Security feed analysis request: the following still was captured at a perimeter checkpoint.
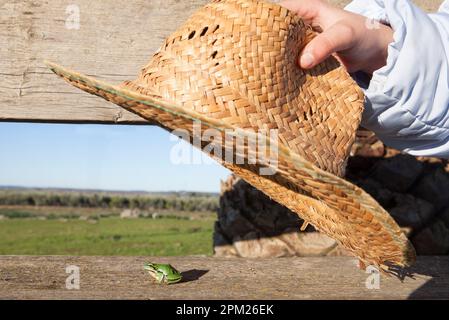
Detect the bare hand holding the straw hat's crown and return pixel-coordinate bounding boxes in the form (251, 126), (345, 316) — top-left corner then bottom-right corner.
(280, 0), (393, 74)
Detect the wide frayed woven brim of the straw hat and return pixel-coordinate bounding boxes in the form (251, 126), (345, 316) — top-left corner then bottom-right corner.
(46, 62), (415, 269)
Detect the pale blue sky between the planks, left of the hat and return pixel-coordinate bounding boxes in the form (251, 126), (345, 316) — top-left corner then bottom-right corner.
(0, 123), (229, 192)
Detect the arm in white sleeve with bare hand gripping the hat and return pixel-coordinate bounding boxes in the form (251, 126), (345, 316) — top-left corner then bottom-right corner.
(281, 0), (449, 158)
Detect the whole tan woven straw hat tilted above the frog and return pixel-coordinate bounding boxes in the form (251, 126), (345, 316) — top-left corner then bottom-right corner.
(48, 0), (415, 269)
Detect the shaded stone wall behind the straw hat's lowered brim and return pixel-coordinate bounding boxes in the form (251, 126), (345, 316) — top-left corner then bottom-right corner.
(214, 130), (449, 257)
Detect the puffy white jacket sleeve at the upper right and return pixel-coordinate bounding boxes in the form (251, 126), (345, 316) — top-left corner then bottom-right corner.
(345, 0), (449, 158)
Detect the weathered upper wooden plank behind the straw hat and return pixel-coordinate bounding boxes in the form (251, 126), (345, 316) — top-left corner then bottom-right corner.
(0, 0), (441, 124)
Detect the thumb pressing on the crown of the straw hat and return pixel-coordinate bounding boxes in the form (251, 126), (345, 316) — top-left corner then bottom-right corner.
(299, 22), (355, 69)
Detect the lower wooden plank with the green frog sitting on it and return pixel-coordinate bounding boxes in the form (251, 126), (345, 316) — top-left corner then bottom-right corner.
(0, 256), (449, 300)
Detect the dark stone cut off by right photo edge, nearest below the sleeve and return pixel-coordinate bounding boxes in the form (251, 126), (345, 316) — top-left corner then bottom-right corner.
(412, 166), (449, 210)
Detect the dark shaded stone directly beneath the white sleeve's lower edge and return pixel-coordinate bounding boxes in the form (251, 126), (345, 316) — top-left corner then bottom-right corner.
(372, 154), (423, 192)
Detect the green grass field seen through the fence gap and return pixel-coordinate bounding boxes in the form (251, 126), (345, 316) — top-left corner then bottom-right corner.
(0, 215), (215, 256)
